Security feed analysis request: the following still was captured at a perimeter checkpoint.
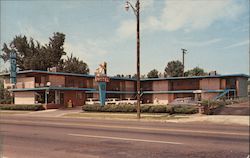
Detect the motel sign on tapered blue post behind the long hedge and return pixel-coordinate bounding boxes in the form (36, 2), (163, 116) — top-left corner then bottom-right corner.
(95, 62), (110, 106)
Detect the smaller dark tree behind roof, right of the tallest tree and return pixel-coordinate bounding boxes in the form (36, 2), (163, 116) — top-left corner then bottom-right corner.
(59, 54), (89, 74)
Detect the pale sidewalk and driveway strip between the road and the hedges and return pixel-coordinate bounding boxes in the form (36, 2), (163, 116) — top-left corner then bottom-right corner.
(2, 107), (250, 126)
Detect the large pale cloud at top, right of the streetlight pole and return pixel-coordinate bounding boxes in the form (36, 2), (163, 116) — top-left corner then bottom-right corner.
(147, 0), (244, 31)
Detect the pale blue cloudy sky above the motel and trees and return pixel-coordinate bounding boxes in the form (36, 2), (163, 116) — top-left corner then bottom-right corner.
(0, 0), (249, 75)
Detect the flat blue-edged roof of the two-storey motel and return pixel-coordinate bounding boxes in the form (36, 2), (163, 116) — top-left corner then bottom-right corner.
(0, 70), (249, 81)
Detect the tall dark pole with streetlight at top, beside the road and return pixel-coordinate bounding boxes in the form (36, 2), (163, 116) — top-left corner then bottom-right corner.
(125, 0), (141, 119)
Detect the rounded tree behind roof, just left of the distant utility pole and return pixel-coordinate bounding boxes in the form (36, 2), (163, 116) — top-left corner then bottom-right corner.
(165, 60), (184, 77)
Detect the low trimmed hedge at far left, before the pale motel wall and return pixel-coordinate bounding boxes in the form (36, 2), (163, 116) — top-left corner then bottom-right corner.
(0, 105), (44, 111)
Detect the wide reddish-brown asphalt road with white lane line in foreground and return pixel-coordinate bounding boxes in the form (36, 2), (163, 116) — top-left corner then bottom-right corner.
(0, 115), (249, 158)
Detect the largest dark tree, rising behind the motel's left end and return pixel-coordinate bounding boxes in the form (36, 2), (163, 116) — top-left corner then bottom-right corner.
(0, 32), (66, 70)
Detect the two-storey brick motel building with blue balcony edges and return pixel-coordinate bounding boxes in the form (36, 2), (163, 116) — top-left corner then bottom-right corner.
(0, 70), (249, 109)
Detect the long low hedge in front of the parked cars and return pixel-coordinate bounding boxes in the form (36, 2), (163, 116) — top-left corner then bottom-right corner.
(82, 104), (198, 114)
